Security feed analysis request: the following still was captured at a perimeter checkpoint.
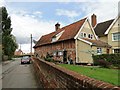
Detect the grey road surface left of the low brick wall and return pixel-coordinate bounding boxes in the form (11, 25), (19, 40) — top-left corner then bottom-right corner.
(2, 59), (40, 88)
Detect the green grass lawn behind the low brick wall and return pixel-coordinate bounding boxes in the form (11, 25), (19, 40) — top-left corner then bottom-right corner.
(60, 64), (120, 86)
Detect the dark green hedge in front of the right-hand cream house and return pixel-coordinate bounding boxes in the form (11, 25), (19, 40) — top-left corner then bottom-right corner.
(93, 54), (120, 65)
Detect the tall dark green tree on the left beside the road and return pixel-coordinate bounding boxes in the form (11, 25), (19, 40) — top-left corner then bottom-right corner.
(1, 7), (18, 59)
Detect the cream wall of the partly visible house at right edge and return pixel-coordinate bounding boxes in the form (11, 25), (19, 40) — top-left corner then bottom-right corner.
(108, 18), (120, 53)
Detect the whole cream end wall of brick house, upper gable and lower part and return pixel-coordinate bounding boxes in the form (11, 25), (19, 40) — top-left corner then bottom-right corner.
(76, 20), (96, 63)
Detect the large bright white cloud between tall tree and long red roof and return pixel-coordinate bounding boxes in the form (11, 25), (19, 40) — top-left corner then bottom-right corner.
(10, 11), (56, 53)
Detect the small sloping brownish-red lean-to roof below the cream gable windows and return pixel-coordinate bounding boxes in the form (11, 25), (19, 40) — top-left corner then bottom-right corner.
(83, 38), (111, 48)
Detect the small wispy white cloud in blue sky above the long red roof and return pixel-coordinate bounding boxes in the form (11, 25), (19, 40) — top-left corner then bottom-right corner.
(56, 9), (79, 18)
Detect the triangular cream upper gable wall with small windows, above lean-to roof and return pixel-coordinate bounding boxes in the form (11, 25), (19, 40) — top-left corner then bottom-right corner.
(79, 20), (95, 40)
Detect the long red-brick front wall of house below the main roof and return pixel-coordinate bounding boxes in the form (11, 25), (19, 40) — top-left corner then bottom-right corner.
(35, 40), (76, 61)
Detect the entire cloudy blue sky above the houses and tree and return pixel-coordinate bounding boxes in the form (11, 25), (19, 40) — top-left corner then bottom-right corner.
(0, 0), (119, 53)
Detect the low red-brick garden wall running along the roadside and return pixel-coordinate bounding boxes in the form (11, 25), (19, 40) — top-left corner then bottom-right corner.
(33, 58), (120, 90)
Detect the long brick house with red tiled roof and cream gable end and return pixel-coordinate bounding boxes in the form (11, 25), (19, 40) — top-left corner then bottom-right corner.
(34, 14), (111, 63)
